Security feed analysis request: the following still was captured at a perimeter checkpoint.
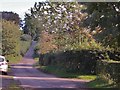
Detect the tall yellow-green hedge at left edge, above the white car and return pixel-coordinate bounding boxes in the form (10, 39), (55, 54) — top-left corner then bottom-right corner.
(2, 20), (20, 56)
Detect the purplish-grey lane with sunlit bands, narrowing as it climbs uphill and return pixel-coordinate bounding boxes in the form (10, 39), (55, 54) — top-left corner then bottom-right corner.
(12, 41), (87, 90)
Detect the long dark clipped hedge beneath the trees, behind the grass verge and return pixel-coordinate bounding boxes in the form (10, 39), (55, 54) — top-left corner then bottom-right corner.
(39, 50), (119, 74)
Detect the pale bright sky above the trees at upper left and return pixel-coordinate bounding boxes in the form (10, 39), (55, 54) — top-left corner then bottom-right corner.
(0, 0), (44, 19)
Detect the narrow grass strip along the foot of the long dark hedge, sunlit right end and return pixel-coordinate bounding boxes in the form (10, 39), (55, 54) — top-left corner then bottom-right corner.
(34, 63), (96, 80)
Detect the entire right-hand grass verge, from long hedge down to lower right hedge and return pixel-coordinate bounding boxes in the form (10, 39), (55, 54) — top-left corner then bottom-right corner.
(34, 62), (116, 88)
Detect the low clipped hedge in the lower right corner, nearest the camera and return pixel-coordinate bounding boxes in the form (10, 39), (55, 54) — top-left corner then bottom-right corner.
(97, 60), (120, 87)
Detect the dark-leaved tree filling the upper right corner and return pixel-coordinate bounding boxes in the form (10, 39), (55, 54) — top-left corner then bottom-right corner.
(84, 2), (120, 48)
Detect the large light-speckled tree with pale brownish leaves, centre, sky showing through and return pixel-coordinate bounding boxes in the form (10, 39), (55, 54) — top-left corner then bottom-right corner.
(26, 2), (102, 50)
